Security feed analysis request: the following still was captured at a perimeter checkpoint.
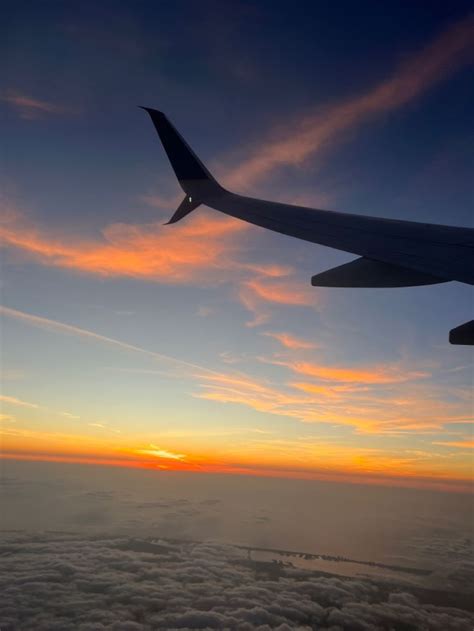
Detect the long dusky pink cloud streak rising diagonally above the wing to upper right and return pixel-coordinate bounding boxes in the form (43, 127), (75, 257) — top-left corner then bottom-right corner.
(223, 16), (474, 189)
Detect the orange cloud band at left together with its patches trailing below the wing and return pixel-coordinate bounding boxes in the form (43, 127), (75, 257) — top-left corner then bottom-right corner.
(0, 207), (304, 325)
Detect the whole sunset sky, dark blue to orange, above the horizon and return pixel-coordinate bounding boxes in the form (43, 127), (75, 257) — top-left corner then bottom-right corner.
(0, 1), (474, 492)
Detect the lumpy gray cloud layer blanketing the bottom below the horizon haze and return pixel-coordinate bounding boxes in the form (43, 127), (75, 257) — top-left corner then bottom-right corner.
(0, 534), (474, 631)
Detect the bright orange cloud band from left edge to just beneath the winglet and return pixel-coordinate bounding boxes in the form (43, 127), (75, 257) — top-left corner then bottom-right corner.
(0, 213), (252, 283)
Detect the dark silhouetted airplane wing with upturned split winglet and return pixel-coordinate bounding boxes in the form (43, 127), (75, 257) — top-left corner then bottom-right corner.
(143, 107), (474, 344)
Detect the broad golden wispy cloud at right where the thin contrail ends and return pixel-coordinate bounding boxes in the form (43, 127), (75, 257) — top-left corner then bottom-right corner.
(194, 368), (464, 436)
